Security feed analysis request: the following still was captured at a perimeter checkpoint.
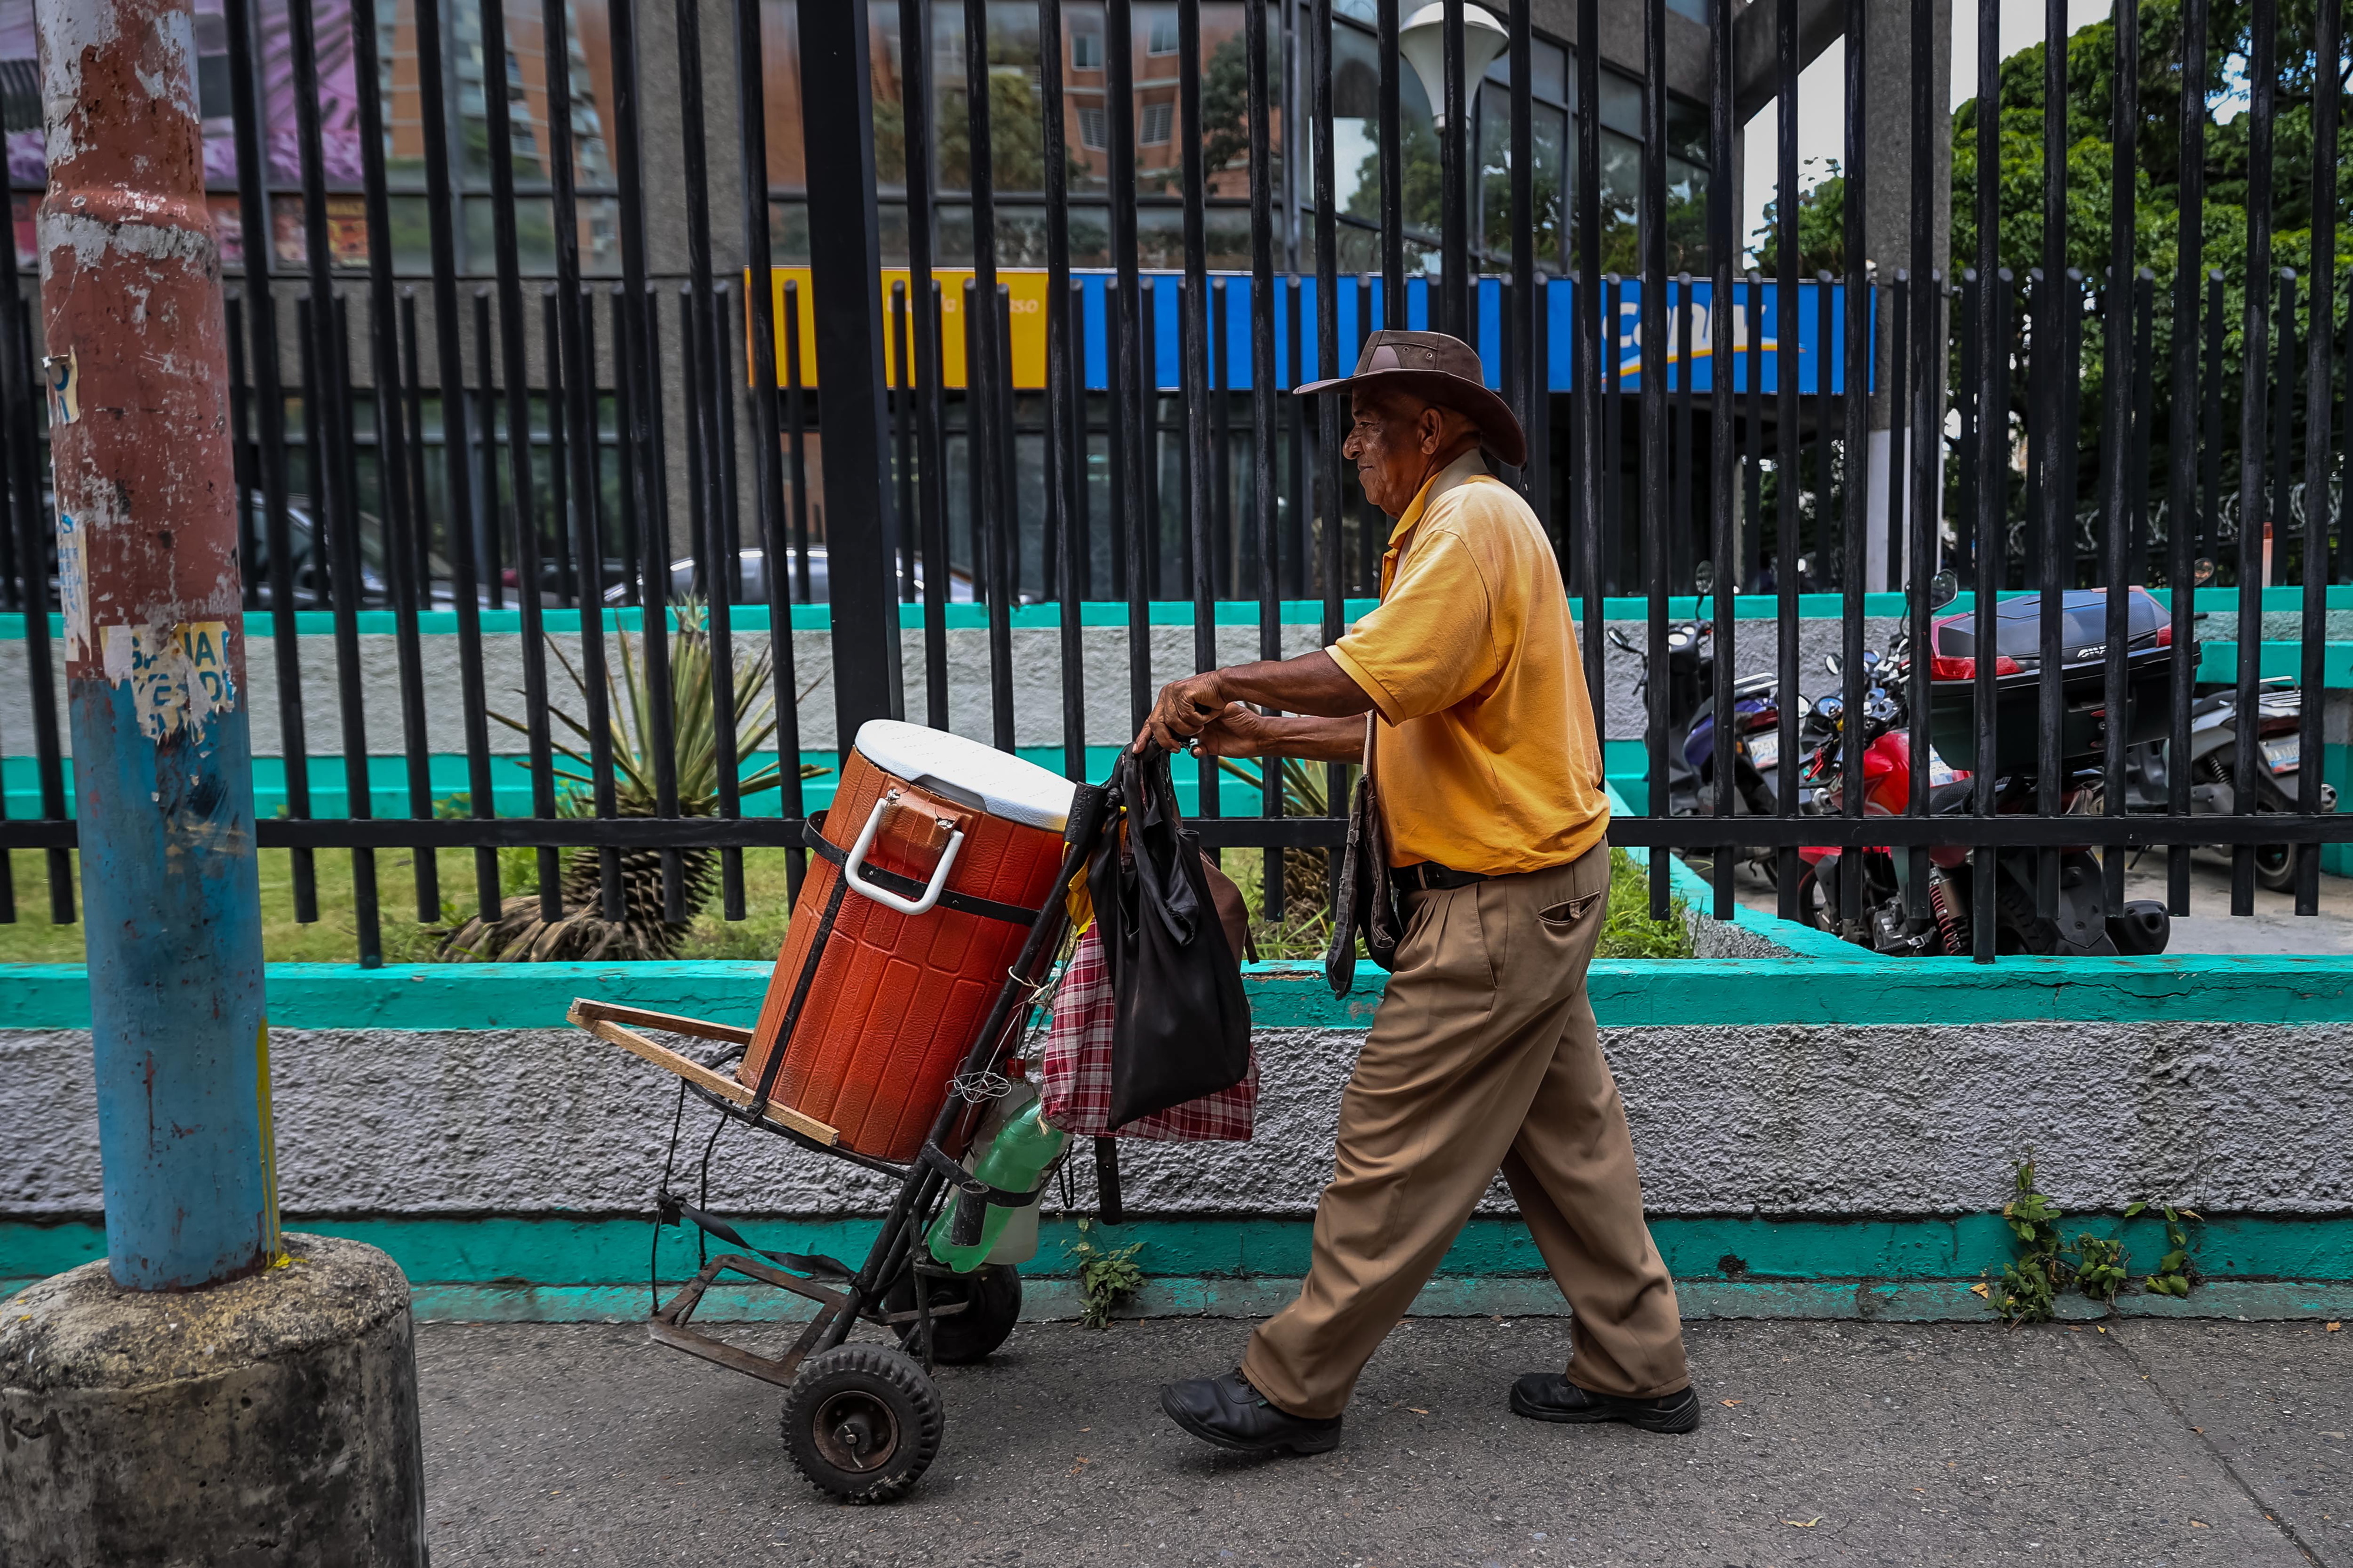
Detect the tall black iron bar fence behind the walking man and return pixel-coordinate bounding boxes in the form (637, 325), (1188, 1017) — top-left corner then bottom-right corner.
(0, 0), (2353, 963)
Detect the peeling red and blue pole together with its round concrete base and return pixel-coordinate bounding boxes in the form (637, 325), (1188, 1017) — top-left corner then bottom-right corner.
(0, 0), (424, 1563)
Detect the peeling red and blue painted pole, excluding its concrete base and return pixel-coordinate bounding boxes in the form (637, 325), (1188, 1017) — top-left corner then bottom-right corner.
(35, 0), (278, 1290)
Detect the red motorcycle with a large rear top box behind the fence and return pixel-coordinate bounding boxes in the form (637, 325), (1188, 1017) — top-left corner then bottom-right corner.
(1798, 591), (2172, 956)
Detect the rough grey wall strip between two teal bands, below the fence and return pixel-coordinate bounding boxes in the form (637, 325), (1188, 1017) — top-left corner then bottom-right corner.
(0, 1022), (2353, 1220)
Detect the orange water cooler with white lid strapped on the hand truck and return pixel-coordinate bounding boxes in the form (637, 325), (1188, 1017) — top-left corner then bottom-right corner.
(736, 718), (1073, 1160)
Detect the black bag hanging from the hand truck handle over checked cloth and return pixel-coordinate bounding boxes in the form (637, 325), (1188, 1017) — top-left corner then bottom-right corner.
(1087, 749), (1249, 1125)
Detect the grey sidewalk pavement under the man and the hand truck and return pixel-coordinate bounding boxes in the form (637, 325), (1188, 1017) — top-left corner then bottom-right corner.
(419, 1319), (2353, 1568)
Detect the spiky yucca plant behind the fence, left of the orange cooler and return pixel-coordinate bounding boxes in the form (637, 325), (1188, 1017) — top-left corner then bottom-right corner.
(440, 600), (826, 963)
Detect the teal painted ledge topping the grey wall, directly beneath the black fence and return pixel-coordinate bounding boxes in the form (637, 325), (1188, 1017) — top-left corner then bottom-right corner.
(0, 946), (2353, 1029)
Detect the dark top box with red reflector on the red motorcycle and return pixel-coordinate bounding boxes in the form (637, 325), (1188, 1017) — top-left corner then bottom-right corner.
(1929, 589), (2198, 772)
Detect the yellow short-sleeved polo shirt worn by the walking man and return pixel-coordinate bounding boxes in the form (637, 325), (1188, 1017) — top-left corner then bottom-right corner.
(1329, 452), (1609, 876)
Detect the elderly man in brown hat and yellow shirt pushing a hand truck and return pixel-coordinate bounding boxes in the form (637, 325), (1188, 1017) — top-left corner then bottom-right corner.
(1136, 332), (1699, 1453)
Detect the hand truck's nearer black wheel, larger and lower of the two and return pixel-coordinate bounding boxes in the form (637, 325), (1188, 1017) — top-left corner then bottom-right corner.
(784, 1345), (946, 1502)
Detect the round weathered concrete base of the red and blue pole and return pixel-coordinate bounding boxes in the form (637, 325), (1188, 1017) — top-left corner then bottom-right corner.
(0, 1234), (426, 1568)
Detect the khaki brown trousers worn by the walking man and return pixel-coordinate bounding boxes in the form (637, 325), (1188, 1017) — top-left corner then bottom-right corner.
(1242, 843), (1692, 1417)
